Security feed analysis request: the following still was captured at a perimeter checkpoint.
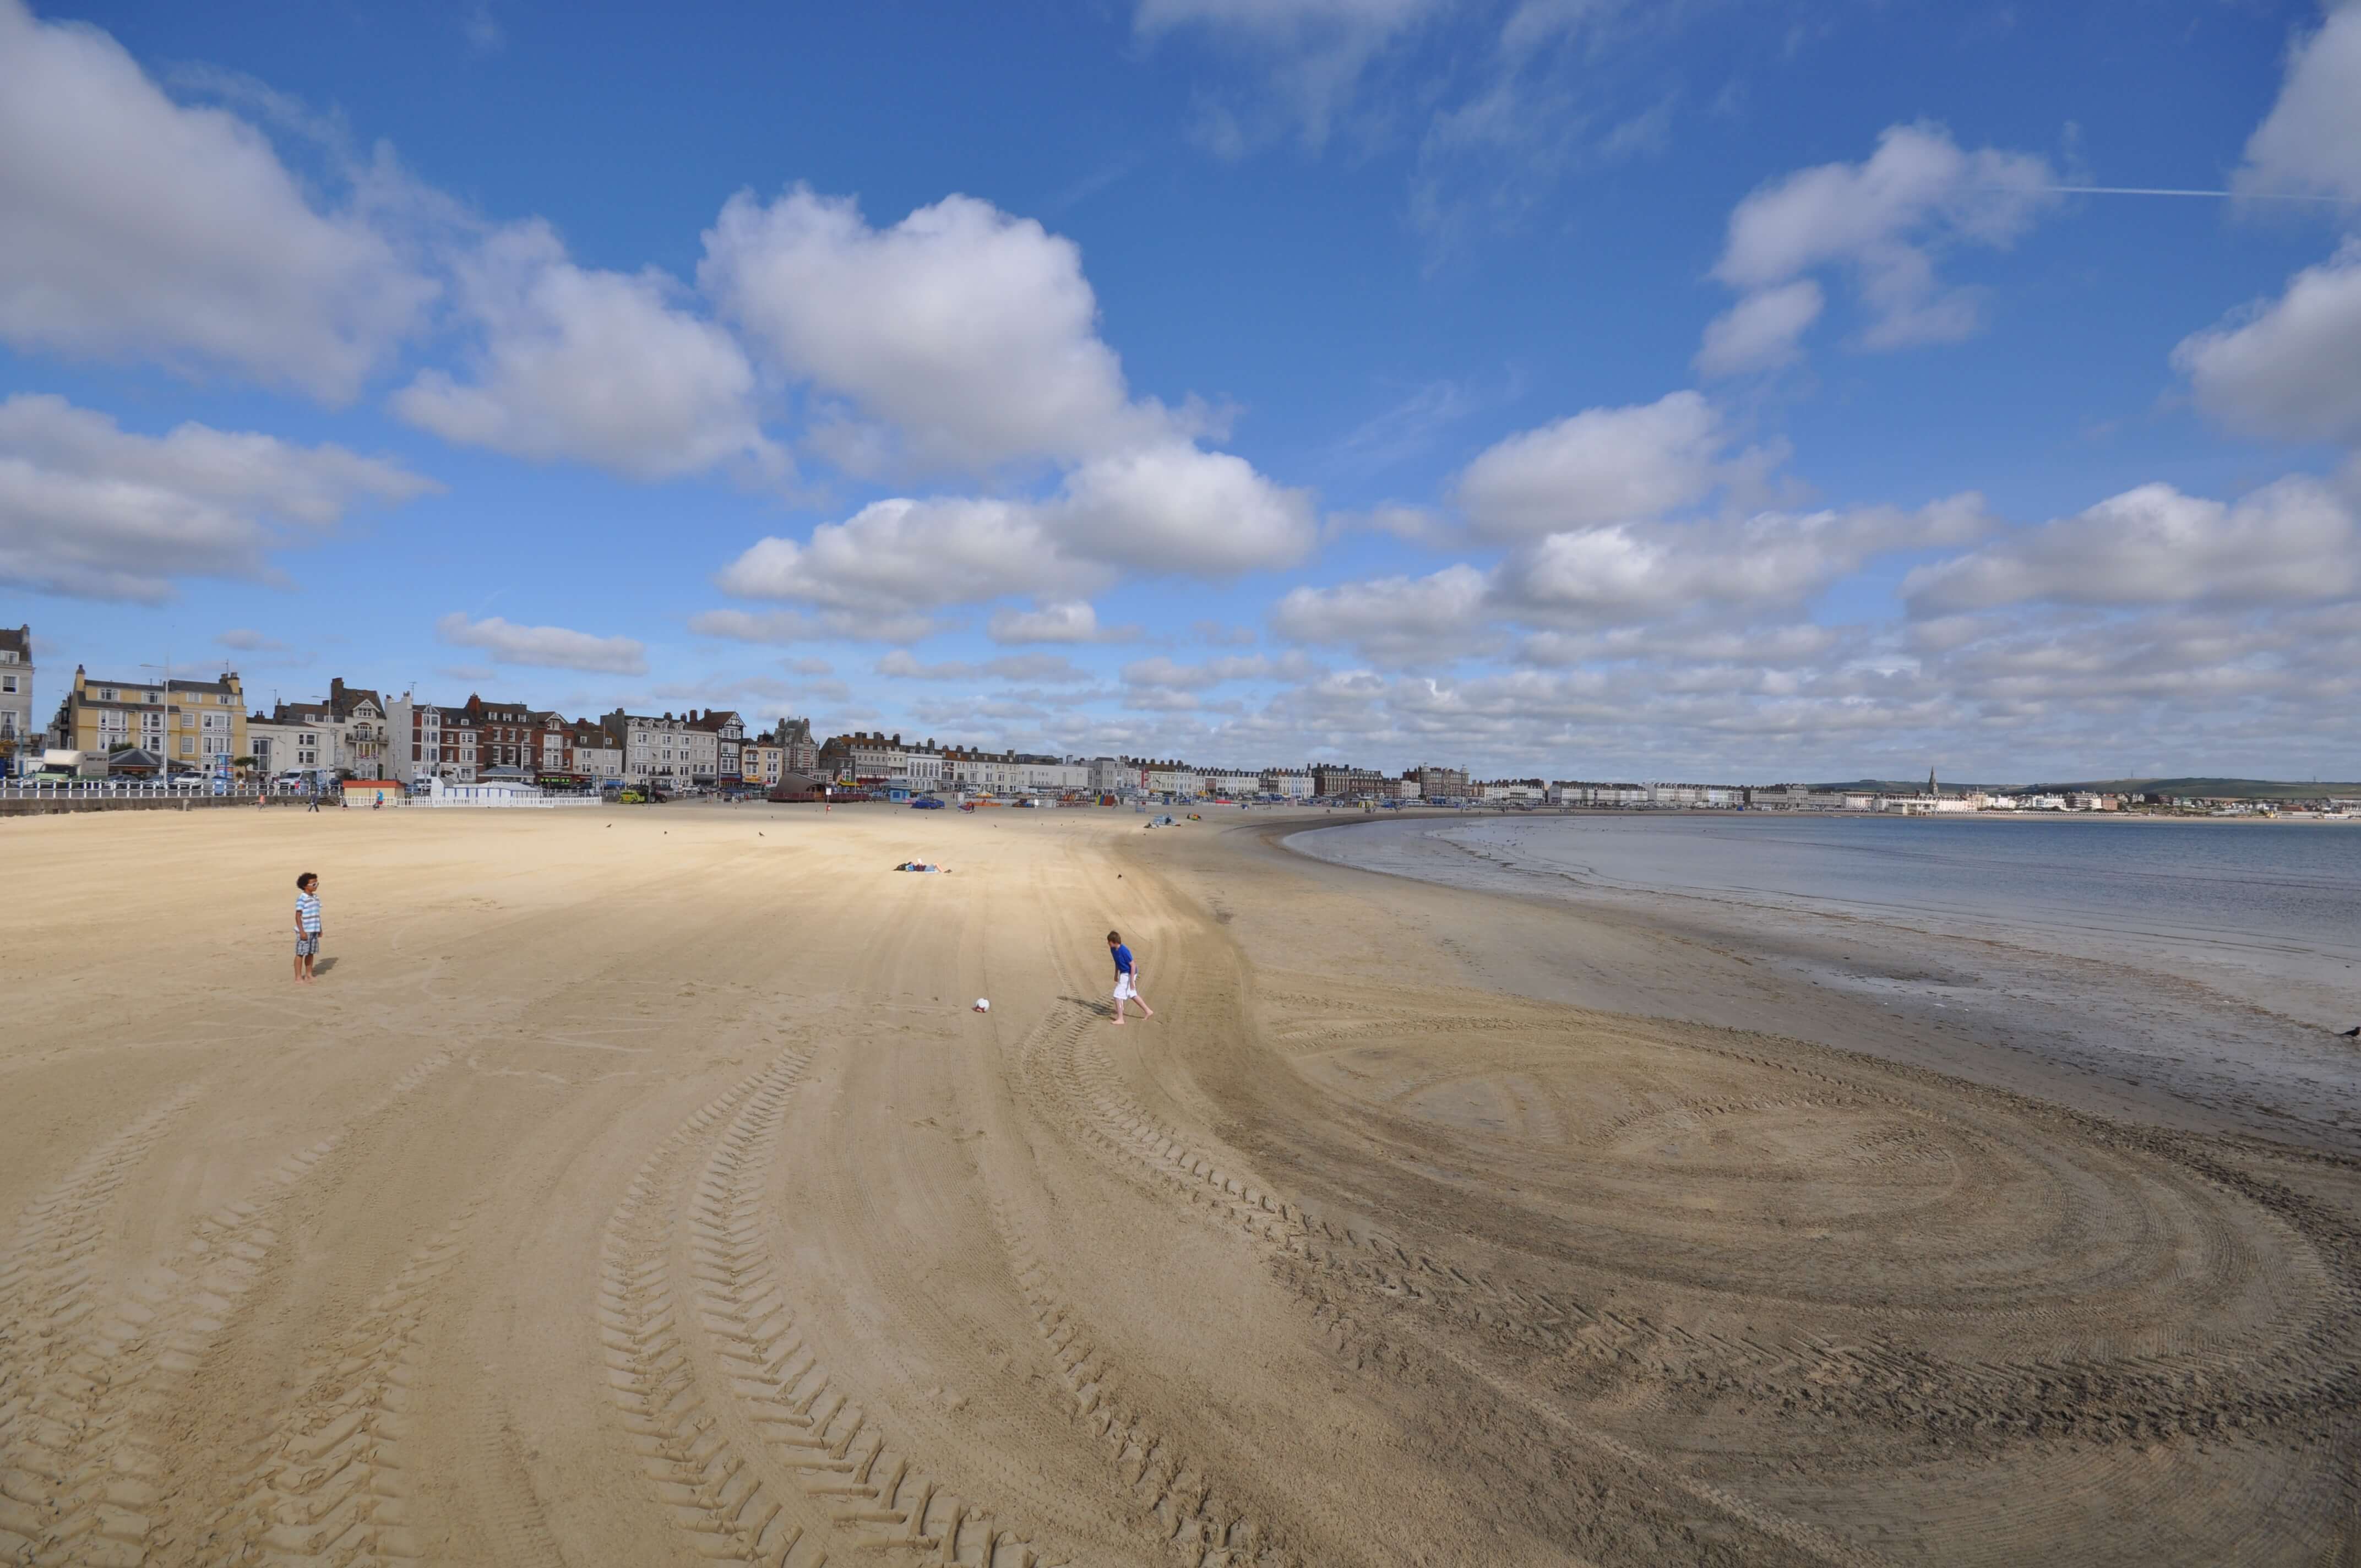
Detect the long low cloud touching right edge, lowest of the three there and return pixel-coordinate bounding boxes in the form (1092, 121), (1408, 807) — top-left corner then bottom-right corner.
(1903, 477), (2361, 616)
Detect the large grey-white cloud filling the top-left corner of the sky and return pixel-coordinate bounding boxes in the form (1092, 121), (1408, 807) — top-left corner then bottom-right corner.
(0, 0), (434, 401)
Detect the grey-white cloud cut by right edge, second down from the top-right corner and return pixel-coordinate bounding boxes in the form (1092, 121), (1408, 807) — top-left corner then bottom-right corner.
(2172, 238), (2361, 442)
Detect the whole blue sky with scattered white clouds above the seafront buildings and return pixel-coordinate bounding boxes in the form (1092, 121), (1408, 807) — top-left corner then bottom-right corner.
(0, 0), (2361, 779)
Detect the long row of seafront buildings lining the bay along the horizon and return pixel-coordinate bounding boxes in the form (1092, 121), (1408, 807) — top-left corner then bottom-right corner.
(23, 647), (2304, 817)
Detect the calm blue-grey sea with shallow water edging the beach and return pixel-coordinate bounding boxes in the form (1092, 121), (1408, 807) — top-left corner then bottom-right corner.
(1289, 812), (2361, 1147)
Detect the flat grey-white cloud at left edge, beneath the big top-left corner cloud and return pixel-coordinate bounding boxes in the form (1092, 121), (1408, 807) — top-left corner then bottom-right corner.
(0, 392), (439, 602)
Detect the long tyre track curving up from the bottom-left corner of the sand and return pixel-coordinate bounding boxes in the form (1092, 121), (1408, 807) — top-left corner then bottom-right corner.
(0, 1051), (456, 1568)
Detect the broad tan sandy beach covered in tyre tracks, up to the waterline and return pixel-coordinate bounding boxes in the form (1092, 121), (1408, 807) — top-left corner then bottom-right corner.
(0, 808), (2361, 1568)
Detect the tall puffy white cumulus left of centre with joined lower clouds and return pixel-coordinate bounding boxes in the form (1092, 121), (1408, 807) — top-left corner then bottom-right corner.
(699, 189), (1318, 618)
